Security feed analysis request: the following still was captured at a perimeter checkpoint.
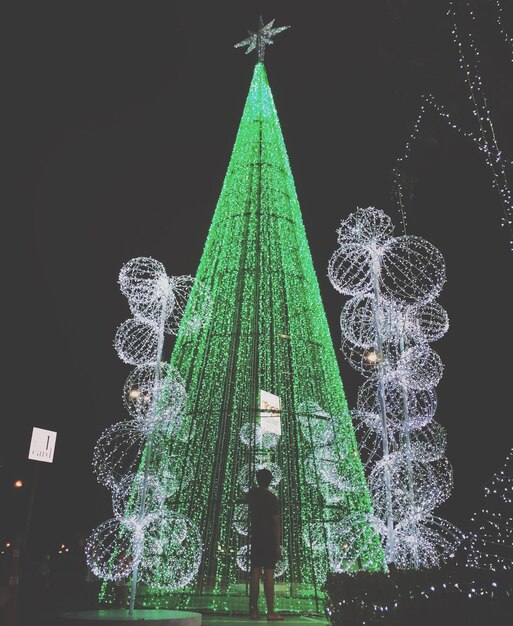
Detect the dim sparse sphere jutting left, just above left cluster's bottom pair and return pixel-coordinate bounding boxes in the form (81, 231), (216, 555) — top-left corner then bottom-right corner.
(93, 420), (145, 489)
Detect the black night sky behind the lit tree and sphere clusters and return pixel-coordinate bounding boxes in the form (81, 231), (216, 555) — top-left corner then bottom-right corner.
(4, 0), (513, 549)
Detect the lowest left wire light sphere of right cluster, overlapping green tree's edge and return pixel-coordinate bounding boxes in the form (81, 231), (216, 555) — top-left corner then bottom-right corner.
(326, 513), (379, 572)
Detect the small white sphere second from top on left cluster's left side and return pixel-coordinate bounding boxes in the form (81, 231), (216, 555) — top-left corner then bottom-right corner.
(114, 319), (159, 365)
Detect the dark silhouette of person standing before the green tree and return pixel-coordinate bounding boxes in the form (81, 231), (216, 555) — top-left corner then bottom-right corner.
(248, 468), (283, 622)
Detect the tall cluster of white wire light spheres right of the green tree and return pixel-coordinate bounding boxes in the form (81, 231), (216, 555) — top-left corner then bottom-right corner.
(328, 207), (461, 571)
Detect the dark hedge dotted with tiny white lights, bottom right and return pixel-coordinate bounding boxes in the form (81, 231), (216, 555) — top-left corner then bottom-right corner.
(326, 568), (513, 626)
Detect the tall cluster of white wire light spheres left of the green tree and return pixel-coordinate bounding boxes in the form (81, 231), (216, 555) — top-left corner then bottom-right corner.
(86, 257), (211, 590)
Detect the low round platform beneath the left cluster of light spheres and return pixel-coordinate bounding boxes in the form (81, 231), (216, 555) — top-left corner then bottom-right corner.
(60, 609), (201, 626)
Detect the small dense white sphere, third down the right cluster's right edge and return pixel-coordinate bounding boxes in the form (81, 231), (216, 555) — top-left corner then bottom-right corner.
(397, 344), (444, 389)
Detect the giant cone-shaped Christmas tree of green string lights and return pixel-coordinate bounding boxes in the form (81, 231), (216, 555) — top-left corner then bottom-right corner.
(156, 62), (384, 606)
